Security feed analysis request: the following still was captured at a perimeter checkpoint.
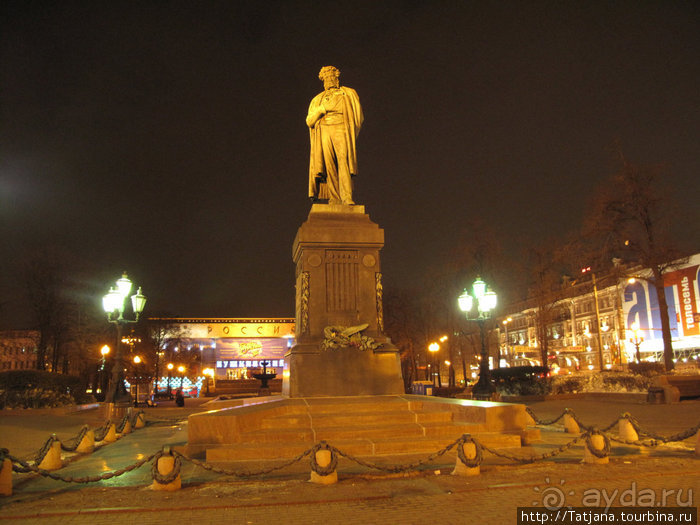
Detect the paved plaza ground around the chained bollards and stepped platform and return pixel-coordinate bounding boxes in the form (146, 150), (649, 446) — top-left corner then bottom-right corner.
(0, 398), (700, 524)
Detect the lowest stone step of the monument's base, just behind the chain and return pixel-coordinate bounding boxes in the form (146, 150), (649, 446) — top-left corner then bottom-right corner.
(206, 432), (520, 463)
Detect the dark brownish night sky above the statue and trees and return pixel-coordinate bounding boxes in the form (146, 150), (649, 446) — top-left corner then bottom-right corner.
(0, 0), (700, 322)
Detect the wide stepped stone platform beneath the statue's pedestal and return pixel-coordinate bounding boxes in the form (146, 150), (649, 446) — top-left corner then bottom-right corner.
(187, 395), (539, 462)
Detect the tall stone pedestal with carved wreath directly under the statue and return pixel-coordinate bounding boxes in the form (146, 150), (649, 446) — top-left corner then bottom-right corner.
(282, 204), (403, 397)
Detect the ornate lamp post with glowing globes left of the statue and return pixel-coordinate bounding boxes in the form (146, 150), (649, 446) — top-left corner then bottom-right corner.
(102, 272), (146, 404)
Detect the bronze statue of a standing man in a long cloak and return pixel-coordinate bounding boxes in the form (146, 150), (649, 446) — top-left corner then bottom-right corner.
(306, 66), (364, 204)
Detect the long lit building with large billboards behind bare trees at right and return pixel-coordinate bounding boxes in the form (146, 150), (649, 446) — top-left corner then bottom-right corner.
(499, 254), (700, 370)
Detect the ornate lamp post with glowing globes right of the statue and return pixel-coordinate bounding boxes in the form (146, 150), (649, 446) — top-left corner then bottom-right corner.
(458, 277), (497, 400)
